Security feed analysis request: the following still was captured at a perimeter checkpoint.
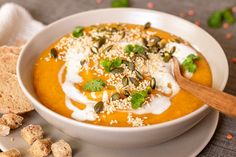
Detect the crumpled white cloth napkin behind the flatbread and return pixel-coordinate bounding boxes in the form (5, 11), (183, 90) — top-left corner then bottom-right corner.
(0, 3), (44, 46)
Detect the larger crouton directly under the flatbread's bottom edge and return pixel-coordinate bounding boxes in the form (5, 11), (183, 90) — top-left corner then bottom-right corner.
(2, 113), (24, 129)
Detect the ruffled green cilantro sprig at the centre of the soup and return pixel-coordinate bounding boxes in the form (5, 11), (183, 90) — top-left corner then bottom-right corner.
(100, 57), (122, 72)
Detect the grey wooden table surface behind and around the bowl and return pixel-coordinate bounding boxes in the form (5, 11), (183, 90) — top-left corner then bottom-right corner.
(0, 0), (236, 157)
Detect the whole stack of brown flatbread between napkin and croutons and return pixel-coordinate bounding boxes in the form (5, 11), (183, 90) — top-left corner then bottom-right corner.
(0, 46), (33, 114)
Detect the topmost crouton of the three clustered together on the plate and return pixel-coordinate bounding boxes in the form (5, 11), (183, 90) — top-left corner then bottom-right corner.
(21, 124), (43, 145)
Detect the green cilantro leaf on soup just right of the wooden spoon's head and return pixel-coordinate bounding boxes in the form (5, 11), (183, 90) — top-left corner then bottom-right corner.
(182, 54), (200, 73)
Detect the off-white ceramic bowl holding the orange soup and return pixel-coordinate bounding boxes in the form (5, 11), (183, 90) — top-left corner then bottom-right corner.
(17, 9), (228, 147)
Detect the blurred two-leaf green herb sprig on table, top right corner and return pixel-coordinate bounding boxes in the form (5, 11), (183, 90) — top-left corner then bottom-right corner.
(208, 8), (235, 28)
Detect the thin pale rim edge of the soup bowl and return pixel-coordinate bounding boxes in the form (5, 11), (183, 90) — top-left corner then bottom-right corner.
(16, 8), (229, 132)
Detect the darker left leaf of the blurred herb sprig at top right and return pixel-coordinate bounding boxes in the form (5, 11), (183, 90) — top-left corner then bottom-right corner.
(208, 11), (223, 28)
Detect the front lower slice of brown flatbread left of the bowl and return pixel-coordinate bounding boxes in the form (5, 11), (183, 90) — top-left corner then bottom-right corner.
(0, 72), (33, 114)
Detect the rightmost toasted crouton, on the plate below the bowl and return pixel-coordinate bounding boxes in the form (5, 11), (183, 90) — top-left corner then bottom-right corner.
(51, 140), (72, 157)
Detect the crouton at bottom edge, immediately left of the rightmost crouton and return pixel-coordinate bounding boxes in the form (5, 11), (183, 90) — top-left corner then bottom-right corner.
(28, 138), (52, 157)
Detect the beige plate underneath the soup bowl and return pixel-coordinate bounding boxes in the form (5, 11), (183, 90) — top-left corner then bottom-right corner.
(0, 111), (219, 157)
